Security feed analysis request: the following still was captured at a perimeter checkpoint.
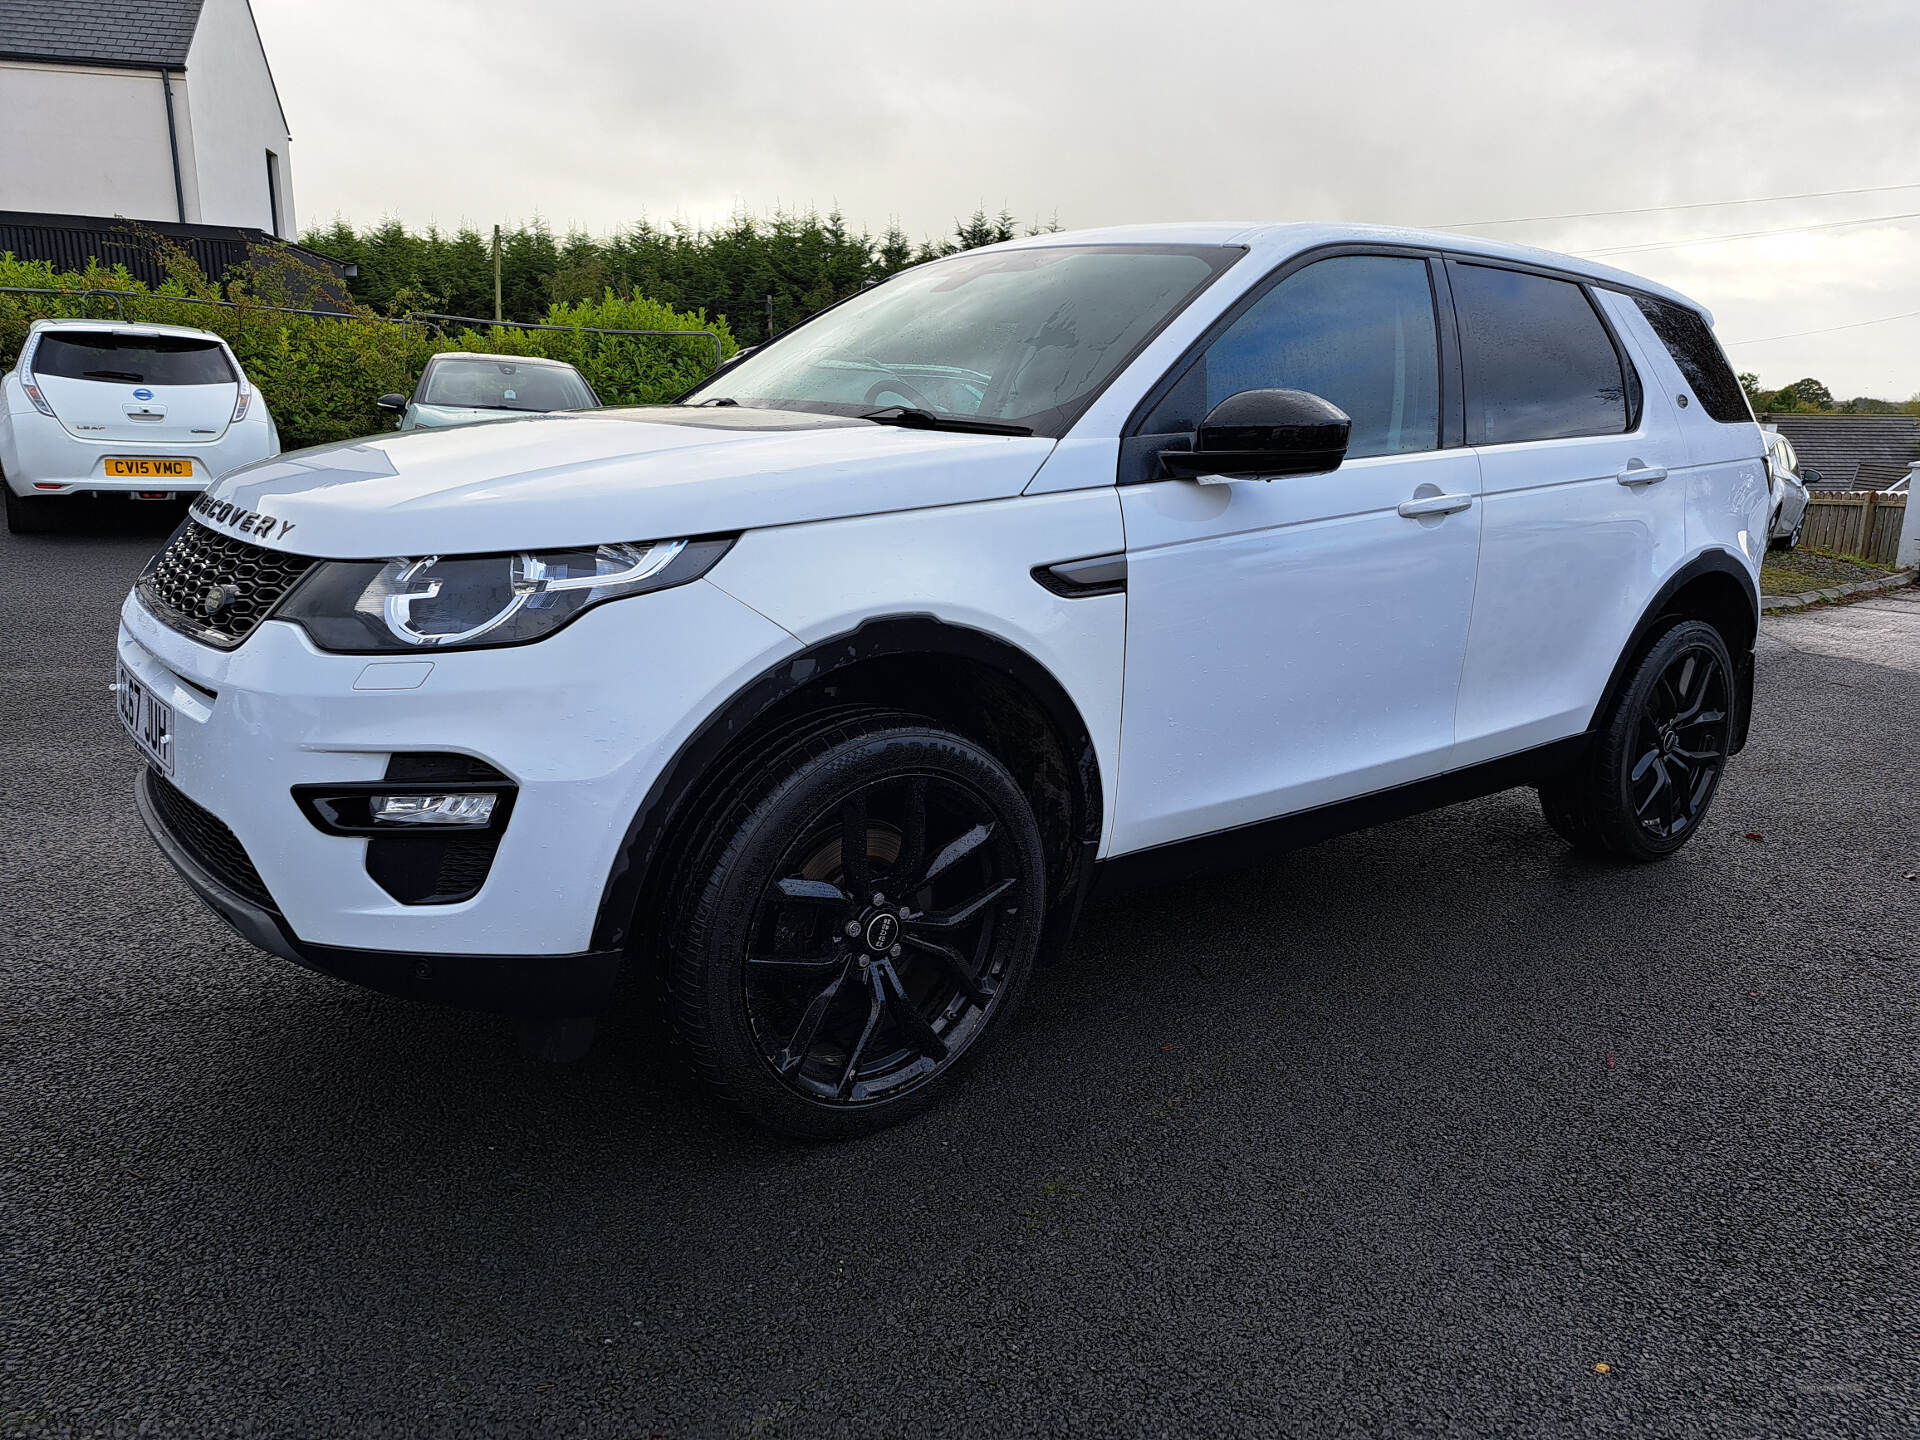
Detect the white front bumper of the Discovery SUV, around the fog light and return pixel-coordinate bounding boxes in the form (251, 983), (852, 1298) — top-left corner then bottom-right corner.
(119, 580), (799, 993)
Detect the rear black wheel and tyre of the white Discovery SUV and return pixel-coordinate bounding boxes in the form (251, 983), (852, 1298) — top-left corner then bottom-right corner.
(1540, 620), (1736, 860)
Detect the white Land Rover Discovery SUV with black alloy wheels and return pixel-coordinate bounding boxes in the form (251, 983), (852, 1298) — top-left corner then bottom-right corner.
(119, 225), (1768, 1135)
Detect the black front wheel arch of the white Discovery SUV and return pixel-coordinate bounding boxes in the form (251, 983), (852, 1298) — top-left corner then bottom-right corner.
(593, 614), (1104, 952)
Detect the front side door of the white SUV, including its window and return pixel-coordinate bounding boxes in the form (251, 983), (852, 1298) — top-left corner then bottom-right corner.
(1110, 252), (1480, 854)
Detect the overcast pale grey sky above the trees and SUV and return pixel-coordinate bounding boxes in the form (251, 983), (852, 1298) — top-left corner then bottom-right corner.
(253, 0), (1920, 399)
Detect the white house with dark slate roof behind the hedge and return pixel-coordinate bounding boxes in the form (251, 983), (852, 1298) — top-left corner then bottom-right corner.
(0, 0), (294, 238)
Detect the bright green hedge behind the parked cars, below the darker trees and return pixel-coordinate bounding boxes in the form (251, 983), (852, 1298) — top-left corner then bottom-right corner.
(0, 255), (737, 449)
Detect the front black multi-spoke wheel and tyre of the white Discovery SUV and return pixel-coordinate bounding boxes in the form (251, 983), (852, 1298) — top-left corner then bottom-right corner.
(660, 712), (1046, 1139)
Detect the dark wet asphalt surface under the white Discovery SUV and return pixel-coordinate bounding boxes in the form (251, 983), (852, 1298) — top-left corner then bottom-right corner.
(0, 510), (1920, 1436)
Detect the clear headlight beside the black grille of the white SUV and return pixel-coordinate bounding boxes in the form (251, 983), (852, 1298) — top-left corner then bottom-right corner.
(275, 538), (733, 653)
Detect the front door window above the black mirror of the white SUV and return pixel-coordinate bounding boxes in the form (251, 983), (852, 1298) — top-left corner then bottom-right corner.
(1142, 255), (1440, 459)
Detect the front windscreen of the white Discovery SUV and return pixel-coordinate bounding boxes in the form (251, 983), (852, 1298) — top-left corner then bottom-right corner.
(685, 246), (1242, 436)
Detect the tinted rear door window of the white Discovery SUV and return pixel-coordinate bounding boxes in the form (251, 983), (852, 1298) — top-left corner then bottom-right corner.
(1452, 265), (1632, 445)
